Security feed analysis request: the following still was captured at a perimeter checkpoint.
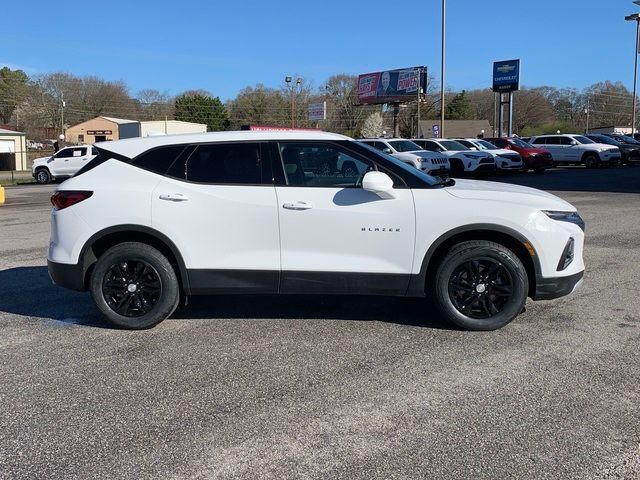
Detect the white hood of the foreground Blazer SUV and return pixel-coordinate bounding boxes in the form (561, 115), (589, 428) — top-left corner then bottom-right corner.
(446, 179), (576, 212)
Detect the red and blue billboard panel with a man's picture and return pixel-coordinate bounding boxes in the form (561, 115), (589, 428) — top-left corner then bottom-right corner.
(358, 67), (426, 103)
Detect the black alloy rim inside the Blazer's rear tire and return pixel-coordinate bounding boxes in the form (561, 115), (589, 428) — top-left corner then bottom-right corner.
(102, 260), (162, 318)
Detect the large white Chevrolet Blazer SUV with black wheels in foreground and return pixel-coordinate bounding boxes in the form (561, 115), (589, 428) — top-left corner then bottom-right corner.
(48, 131), (584, 330)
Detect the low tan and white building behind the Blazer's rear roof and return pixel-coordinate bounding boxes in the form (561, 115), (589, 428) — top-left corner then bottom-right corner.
(65, 117), (207, 144)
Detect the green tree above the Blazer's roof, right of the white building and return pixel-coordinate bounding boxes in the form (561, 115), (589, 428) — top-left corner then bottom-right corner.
(175, 91), (230, 131)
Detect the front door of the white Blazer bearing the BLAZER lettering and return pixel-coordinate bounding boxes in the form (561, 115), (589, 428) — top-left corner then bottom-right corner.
(272, 141), (415, 294)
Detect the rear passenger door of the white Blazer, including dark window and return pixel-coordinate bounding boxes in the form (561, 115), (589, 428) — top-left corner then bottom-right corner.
(151, 142), (280, 293)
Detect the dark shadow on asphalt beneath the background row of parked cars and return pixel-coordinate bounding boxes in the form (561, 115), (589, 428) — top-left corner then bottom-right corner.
(486, 165), (640, 193)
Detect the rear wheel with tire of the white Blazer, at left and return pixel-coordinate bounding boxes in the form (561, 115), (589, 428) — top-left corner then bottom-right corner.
(90, 242), (180, 330)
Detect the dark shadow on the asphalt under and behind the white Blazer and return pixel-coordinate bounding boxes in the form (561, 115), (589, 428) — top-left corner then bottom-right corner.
(0, 267), (457, 330)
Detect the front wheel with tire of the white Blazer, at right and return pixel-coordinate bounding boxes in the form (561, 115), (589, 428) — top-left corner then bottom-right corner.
(431, 240), (529, 331)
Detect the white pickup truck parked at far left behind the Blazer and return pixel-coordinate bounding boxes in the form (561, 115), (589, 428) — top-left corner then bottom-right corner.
(31, 145), (98, 184)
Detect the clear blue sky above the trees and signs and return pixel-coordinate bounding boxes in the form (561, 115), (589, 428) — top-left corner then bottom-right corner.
(0, 0), (640, 100)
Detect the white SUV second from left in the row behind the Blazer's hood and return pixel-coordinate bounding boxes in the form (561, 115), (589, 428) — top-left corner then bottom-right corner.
(411, 138), (496, 176)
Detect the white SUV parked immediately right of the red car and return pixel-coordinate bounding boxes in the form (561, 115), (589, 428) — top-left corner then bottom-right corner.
(531, 134), (620, 168)
